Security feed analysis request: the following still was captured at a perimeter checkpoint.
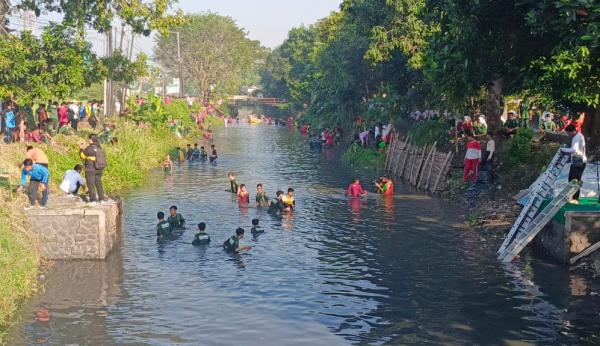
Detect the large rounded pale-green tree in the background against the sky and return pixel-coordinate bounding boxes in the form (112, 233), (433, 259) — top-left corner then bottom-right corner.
(154, 12), (266, 99)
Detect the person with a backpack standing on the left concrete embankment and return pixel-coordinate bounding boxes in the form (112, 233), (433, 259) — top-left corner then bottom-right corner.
(79, 134), (106, 203)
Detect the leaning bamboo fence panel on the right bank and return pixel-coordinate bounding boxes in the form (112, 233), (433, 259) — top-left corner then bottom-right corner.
(385, 137), (454, 192)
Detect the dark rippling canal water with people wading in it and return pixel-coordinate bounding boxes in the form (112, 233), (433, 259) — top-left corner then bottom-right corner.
(9, 125), (600, 345)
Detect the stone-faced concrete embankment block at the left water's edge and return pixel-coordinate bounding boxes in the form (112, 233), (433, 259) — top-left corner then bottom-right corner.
(26, 201), (123, 260)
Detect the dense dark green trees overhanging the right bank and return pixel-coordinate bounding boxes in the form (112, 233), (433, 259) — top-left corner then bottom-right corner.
(261, 0), (600, 137)
